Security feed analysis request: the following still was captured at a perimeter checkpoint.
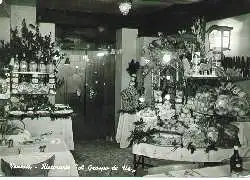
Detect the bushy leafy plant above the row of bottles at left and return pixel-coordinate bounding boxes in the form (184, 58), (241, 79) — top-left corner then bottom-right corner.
(0, 19), (63, 78)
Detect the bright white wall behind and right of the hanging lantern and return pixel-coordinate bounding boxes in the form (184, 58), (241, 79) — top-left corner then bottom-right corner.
(207, 13), (250, 56)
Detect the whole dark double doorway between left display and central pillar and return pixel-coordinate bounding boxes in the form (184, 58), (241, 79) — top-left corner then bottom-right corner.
(57, 51), (115, 140)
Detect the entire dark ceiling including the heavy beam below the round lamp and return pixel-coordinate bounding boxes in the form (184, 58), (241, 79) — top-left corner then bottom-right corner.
(37, 0), (250, 48)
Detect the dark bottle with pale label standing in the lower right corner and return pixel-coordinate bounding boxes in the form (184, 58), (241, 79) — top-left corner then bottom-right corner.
(230, 146), (243, 176)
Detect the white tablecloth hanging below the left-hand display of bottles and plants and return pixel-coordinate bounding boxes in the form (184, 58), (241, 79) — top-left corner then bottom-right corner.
(23, 117), (74, 150)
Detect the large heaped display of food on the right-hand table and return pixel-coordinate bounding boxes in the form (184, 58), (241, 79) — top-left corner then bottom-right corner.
(132, 83), (249, 153)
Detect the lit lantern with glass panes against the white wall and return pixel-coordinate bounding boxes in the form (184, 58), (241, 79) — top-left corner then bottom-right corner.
(208, 25), (233, 51)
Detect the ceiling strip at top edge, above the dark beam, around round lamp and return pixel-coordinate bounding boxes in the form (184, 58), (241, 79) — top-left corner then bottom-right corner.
(38, 0), (201, 15)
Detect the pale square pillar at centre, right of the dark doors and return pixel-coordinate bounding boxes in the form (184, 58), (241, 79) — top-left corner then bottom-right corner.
(115, 28), (138, 134)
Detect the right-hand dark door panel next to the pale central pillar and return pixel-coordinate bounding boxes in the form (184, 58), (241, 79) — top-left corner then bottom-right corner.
(84, 51), (115, 139)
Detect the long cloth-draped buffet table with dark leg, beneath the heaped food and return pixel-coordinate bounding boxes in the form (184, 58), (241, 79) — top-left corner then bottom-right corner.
(132, 122), (250, 173)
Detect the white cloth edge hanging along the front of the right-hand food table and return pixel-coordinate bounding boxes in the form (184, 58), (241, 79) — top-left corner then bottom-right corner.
(132, 143), (250, 162)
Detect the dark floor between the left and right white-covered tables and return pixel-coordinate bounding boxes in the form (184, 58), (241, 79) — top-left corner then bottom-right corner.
(72, 140), (179, 177)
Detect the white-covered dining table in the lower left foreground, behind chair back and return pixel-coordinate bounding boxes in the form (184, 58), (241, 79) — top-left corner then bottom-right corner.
(0, 137), (79, 177)
